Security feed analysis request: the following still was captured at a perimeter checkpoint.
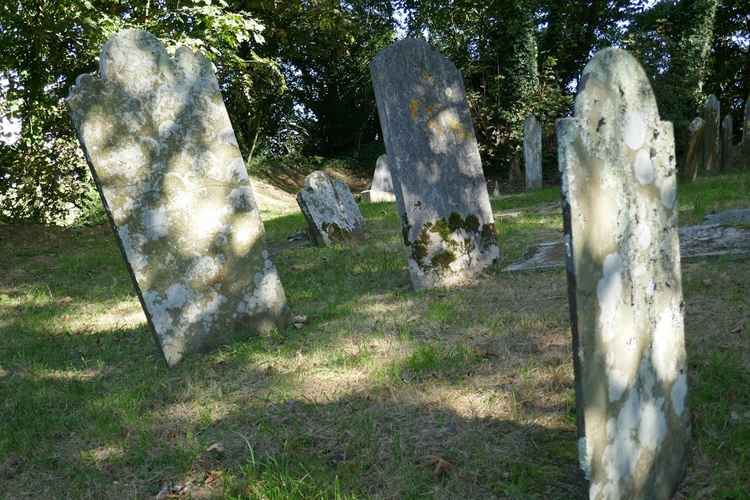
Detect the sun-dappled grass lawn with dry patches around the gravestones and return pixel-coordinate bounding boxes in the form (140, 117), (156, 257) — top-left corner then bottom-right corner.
(0, 174), (750, 499)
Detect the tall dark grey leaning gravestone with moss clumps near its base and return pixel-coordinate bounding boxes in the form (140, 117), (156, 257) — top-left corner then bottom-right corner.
(370, 39), (500, 289)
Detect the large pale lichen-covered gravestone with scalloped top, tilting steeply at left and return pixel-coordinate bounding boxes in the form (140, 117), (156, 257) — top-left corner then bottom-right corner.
(67, 30), (287, 366)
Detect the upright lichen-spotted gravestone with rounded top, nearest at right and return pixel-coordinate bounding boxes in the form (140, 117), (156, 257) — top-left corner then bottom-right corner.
(557, 49), (690, 500)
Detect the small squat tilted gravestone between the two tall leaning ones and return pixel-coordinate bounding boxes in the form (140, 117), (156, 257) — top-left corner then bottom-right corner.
(297, 171), (364, 246)
